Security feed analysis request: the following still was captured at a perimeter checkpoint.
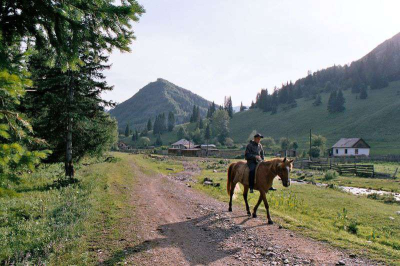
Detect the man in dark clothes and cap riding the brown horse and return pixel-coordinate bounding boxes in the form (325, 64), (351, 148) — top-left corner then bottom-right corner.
(244, 133), (276, 193)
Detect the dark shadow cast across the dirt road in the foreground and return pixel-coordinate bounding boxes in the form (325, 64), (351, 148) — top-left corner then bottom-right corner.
(99, 214), (247, 265)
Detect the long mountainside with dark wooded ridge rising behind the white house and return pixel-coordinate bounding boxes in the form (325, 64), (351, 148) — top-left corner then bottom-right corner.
(230, 33), (400, 155)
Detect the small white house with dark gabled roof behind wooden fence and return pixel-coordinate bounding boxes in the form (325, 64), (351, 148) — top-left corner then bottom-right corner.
(332, 138), (371, 157)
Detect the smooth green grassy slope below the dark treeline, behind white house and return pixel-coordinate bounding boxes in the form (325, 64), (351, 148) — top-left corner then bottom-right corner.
(230, 81), (400, 155)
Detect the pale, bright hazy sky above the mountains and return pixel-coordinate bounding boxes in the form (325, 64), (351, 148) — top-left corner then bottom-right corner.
(103, 0), (400, 106)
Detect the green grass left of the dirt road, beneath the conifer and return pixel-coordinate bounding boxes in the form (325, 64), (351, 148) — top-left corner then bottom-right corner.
(0, 154), (138, 265)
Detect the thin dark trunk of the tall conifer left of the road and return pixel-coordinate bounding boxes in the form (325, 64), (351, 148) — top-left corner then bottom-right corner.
(65, 70), (75, 178)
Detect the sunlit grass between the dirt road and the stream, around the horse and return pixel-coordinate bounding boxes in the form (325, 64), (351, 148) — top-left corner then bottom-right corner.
(195, 158), (400, 264)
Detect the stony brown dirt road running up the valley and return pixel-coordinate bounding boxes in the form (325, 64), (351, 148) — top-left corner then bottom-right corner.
(120, 163), (373, 265)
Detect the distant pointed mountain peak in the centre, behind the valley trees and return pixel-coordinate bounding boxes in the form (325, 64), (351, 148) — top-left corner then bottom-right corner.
(110, 78), (210, 129)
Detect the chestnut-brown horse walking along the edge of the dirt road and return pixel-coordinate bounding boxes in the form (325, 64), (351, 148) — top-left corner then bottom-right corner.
(226, 157), (293, 224)
